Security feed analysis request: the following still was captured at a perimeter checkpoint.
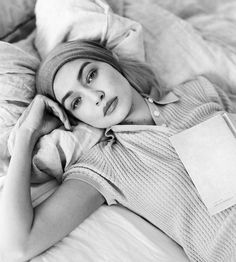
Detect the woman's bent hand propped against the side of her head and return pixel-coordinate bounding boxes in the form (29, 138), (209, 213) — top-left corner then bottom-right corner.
(17, 95), (71, 138)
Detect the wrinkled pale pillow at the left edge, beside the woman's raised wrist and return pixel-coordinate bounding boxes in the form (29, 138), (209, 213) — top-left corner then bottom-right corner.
(0, 41), (39, 177)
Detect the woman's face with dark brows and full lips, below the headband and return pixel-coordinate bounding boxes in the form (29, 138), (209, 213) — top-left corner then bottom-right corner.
(53, 59), (136, 128)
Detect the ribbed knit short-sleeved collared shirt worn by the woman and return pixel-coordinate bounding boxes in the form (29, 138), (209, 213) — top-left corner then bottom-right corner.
(63, 77), (236, 262)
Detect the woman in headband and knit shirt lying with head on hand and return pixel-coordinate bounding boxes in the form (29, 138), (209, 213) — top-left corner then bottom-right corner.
(0, 38), (236, 262)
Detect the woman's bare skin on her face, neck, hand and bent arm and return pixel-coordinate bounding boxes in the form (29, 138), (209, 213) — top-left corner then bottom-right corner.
(0, 60), (153, 262)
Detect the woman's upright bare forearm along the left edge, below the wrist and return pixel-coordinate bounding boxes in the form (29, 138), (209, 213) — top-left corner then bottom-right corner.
(0, 130), (37, 252)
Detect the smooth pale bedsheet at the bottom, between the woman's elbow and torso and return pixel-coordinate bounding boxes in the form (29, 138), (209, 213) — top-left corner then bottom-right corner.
(31, 205), (189, 262)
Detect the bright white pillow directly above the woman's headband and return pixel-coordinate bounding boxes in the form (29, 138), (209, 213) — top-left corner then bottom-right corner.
(35, 0), (144, 60)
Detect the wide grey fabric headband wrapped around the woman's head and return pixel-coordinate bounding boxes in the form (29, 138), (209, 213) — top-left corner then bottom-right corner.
(36, 40), (122, 99)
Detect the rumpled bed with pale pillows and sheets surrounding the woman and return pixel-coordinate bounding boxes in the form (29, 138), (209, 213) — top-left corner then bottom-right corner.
(0, 0), (236, 262)
